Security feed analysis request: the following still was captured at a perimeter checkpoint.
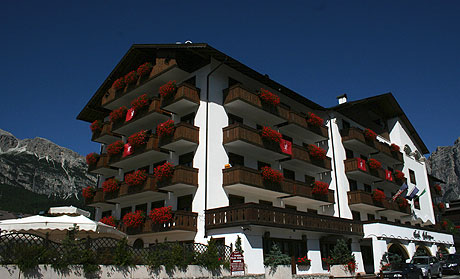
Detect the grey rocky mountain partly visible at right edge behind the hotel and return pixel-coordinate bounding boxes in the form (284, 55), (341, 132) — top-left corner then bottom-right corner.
(427, 138), (460, 201)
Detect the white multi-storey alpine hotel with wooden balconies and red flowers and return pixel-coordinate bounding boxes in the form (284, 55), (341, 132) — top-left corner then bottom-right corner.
(78, 44), (455, 274)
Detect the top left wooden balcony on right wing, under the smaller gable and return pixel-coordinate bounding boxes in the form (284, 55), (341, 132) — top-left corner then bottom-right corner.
(340, 127), (378, 154)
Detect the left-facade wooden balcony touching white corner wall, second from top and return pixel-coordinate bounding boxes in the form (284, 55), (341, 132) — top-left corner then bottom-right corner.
(160, 122), (200, 154)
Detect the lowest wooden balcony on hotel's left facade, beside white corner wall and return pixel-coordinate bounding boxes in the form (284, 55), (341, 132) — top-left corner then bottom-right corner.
(119, 210), (198, 235)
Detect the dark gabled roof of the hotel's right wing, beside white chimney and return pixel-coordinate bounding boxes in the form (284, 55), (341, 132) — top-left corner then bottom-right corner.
(330, 92), (429, 154)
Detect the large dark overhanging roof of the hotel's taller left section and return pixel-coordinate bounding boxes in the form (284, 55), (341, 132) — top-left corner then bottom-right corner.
(77, 43), (324, 122)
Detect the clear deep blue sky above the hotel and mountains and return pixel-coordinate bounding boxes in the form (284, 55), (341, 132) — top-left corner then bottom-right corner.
(0, 0), (460, 155)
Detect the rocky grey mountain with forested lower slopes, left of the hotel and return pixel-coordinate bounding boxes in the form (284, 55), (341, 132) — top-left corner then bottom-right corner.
(0, 129), (96, 214)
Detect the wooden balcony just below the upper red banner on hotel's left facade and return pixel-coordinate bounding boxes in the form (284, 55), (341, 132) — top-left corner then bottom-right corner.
(112, 98), (171, 136)
